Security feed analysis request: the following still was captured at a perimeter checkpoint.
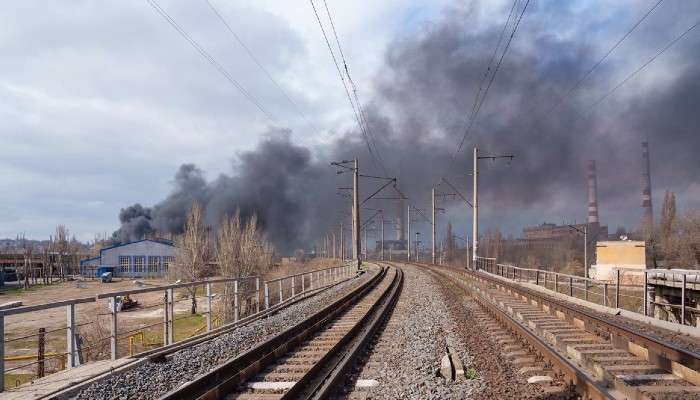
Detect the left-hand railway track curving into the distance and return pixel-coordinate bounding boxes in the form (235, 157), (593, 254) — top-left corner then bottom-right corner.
(160, 266), (403, 400)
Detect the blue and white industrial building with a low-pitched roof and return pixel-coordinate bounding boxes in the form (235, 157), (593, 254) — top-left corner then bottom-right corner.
(80, 239), (175, 278)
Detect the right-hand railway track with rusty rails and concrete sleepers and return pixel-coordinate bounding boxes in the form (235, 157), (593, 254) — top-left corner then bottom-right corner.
(422, 265), (700, 400)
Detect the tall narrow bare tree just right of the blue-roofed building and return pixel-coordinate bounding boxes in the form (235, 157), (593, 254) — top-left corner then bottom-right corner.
(171, 202), (211, 314)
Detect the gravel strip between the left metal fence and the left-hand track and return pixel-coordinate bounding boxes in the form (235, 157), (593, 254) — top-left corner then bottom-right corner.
(76, 272), (373, 400)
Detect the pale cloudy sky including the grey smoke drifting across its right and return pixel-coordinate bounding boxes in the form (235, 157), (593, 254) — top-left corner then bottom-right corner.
(0, 0), (700, 245)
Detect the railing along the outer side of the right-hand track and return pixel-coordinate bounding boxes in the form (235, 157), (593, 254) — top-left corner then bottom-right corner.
(475, 257), (700, 325)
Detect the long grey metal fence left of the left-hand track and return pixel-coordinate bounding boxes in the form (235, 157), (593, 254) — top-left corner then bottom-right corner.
(0, 265), (355, 391)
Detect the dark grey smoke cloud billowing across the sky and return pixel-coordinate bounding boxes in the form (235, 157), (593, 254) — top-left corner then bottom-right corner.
(115, 2), (700, 251)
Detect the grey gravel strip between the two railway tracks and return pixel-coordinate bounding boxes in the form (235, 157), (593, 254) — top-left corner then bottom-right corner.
(344, 266), (482, 399)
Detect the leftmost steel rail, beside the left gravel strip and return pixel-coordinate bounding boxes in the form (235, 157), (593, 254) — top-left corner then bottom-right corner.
(159, 268), (386, 400)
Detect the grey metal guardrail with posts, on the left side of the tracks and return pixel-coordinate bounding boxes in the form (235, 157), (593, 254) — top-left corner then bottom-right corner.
(0, 265), (355, 392)
